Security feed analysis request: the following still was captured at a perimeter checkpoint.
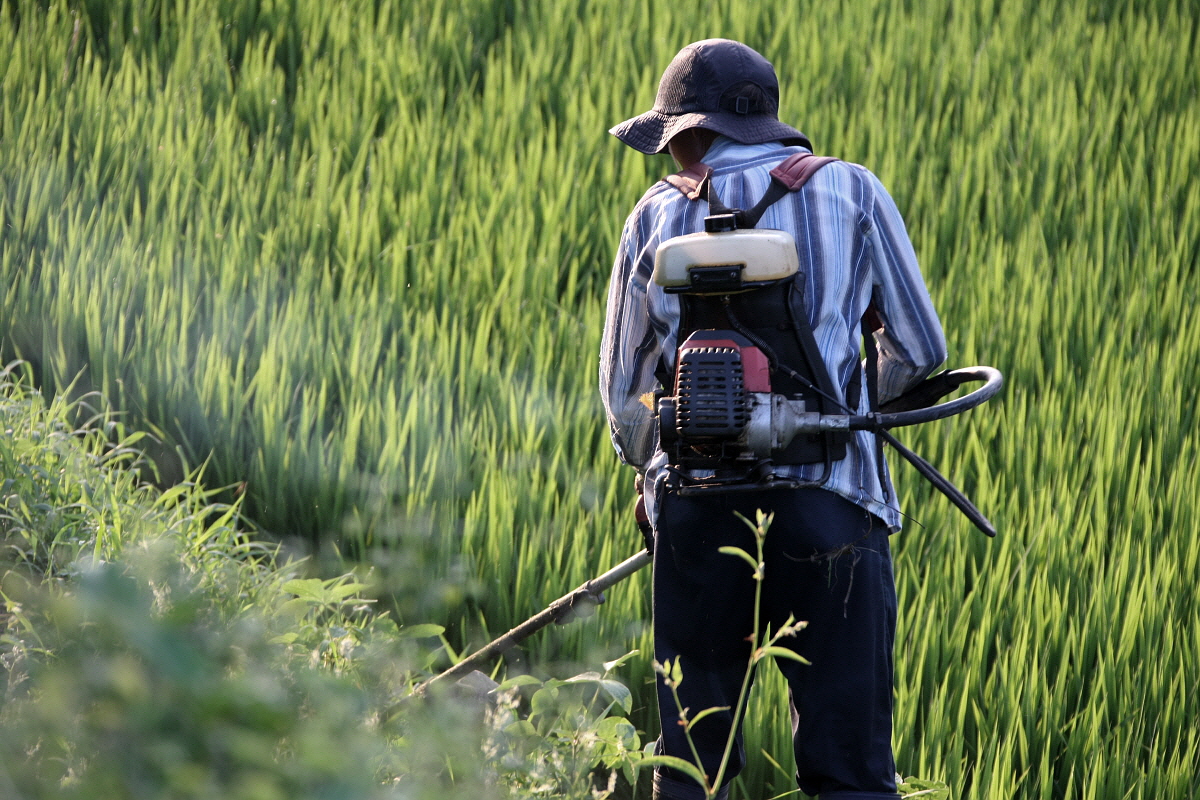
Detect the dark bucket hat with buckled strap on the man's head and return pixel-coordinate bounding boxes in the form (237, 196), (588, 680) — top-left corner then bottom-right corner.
(608, 38), (812, 155)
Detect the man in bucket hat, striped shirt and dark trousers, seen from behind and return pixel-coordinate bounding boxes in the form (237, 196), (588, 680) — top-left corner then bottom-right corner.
(600, 40), (946, 800)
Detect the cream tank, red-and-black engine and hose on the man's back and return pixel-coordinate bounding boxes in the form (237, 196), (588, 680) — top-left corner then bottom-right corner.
(654, 217), (1003, 536)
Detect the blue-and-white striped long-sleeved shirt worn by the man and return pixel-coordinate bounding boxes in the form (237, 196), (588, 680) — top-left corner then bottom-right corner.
(600, 137), (946, 530)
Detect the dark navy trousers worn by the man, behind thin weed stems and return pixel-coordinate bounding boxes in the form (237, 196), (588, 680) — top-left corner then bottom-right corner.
(654, 489), (899, 800)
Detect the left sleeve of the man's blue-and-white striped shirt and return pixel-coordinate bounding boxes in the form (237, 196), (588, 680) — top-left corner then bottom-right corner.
(600, 211), (661, 473)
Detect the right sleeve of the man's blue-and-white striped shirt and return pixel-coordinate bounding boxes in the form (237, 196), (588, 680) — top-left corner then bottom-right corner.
(869, 175), (946, 403)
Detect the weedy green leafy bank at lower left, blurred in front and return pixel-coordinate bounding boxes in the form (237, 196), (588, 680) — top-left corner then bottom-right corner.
(0, 374), (638, 800)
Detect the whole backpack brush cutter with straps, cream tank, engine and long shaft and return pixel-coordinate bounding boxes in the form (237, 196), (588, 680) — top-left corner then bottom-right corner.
(414, 154), (1003, 694)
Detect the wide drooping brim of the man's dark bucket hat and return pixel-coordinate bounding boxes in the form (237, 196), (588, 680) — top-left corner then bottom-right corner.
(608, 109), (812, 156)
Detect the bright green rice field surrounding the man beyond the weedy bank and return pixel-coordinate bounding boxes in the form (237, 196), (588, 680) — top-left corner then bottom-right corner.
(0, 0), (1200, 800)
